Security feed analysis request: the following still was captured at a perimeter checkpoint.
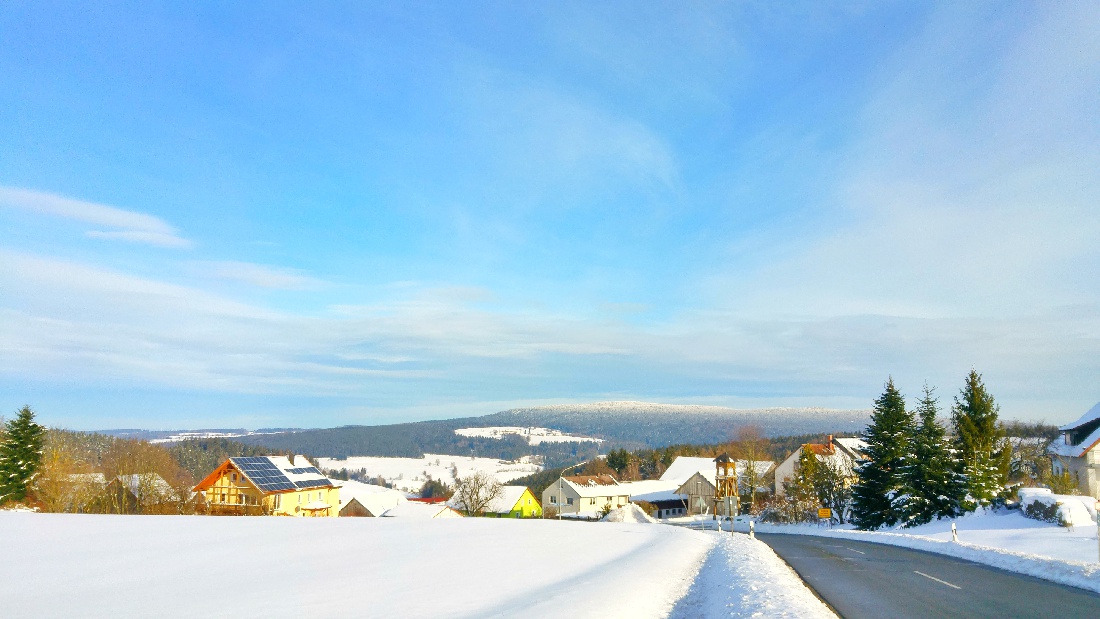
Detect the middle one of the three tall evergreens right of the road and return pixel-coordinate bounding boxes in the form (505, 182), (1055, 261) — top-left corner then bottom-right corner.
(904, 385), (966, 527)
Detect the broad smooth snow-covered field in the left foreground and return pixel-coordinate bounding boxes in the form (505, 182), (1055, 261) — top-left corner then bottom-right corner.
(0, 512), (715, 619)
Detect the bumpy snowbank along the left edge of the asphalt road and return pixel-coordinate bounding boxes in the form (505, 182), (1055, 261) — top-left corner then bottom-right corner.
(669, 532), (836, 619)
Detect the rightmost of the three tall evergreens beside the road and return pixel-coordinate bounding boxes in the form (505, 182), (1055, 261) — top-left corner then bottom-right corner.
(952, 369), (1012, 510)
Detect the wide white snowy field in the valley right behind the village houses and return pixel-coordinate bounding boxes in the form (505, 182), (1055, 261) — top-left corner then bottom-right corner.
(317, 454), (542, 493)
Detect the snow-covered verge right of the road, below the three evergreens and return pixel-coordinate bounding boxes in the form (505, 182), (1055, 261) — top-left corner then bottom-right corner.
(738, 511), (1100, 593)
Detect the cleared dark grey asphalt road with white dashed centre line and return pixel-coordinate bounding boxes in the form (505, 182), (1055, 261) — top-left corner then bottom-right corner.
(757, 533), (1100, 619)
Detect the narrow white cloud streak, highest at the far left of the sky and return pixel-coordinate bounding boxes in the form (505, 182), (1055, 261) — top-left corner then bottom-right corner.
(0, 186), (193, 248)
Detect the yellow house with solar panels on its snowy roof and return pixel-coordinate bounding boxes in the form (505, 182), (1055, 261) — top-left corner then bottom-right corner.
(195, 455), (340, 518)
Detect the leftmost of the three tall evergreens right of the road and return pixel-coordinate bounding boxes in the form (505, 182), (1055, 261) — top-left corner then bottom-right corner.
(851, 378), (914, 529)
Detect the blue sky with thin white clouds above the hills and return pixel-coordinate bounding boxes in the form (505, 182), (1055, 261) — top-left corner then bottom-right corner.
(0, 1), (1100, 429)
